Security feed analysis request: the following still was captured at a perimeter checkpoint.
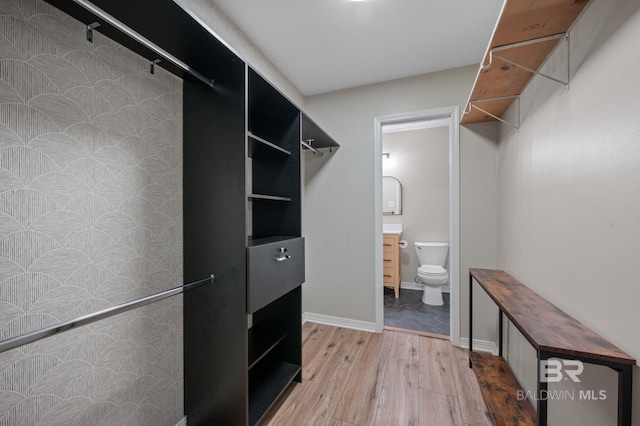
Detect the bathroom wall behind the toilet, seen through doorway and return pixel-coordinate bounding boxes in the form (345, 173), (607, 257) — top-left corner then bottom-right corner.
(382, 126), (450, 283)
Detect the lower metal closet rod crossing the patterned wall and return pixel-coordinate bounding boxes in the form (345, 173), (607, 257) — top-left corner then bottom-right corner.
(0, 274), (215, 353)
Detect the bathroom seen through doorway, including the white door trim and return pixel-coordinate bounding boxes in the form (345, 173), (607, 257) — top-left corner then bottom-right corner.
(374, 107), (460, 344)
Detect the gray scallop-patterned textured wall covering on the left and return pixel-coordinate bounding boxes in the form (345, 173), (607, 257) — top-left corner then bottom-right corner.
(0, 0), (183, 426)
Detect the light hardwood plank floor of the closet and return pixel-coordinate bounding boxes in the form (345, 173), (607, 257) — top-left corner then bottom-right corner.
(261, 322), (492, 426)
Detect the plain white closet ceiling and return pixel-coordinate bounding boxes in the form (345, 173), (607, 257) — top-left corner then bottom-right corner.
(213, 0), (503, 96)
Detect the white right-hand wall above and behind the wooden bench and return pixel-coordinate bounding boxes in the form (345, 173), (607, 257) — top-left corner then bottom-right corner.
(498, 0), (640, 426)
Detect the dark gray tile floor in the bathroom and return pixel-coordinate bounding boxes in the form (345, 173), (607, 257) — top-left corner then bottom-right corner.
(384, 287), (449, 336)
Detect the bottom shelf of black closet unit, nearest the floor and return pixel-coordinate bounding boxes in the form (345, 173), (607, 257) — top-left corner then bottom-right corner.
(249, 362), (302, 425)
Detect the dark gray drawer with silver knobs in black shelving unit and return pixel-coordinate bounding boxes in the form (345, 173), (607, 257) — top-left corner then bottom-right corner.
(247, 237), (304, 313)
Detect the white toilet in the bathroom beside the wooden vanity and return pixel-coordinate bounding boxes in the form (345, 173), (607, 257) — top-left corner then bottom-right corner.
(414, 242), (449, 306)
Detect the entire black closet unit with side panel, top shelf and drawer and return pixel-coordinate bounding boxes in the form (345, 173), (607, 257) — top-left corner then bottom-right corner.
(41, 0), (338, 426)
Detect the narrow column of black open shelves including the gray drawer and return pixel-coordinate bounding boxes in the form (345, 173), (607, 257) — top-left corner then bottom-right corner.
(247, 67), (304, 424)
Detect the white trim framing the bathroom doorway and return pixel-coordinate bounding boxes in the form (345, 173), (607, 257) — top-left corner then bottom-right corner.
(374, 106), (460, 346)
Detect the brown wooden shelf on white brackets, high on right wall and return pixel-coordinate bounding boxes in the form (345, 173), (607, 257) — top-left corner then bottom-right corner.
(460, 0), (589, 128)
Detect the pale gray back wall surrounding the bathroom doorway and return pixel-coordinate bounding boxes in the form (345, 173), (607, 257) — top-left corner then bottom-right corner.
(303, 66), (497, 338)
